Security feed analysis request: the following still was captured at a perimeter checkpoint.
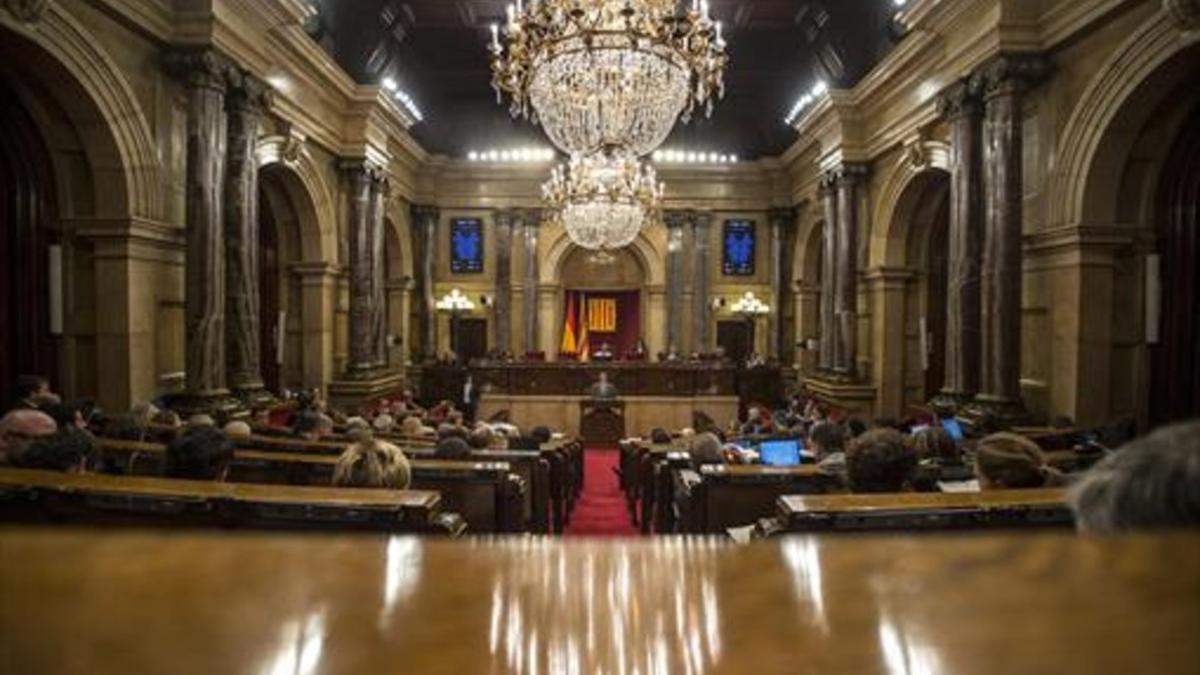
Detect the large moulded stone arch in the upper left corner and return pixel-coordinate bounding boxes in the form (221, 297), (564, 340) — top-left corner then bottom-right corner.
(0, 2), (164, 220)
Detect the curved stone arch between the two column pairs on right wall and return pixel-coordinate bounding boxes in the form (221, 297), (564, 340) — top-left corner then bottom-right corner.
(868, 141), (950, 267)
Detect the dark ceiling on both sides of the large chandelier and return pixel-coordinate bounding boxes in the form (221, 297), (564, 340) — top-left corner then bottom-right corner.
(310, 0), (895, 159)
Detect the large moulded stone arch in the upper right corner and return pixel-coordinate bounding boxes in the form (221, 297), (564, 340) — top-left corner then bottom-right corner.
(1046, 11), (1200, 228)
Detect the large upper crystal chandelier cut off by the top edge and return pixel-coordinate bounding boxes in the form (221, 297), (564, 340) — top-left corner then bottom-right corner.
(491, 0), (728, 156)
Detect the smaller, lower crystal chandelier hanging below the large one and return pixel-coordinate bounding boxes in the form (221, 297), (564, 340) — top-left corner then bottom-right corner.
(541, 153), (662, 251)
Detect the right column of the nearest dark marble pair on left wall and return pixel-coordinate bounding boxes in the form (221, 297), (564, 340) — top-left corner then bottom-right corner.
(224, 71), (272, 404)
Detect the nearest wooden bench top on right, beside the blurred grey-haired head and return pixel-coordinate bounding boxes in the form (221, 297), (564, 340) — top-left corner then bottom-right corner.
(778, 488), (1074, 532)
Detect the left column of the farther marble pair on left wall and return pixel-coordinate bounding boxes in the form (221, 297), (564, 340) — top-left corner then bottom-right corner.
(342, 161), (386, 377)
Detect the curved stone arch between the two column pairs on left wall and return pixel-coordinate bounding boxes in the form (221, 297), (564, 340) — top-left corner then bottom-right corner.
(256, 136), (338, 263)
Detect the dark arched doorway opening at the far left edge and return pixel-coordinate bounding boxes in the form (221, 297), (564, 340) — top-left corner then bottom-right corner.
(0, 79), (62, 399)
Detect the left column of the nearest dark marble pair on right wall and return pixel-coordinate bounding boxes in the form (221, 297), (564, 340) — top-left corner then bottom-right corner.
(931, 80), (983, 414)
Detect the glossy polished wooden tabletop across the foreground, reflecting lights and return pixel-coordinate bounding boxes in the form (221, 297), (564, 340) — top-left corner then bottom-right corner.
(0, 528), (1200, 675)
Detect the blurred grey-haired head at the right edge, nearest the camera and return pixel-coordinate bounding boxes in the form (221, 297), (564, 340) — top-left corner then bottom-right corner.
(1068, 422), (1200, 534)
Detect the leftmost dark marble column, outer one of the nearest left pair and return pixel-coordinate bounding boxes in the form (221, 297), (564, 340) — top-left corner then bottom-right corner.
(173, 50), (234, 412)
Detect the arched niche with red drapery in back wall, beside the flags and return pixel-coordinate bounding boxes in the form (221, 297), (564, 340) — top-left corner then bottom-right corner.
(562, 247), (648, 356)
